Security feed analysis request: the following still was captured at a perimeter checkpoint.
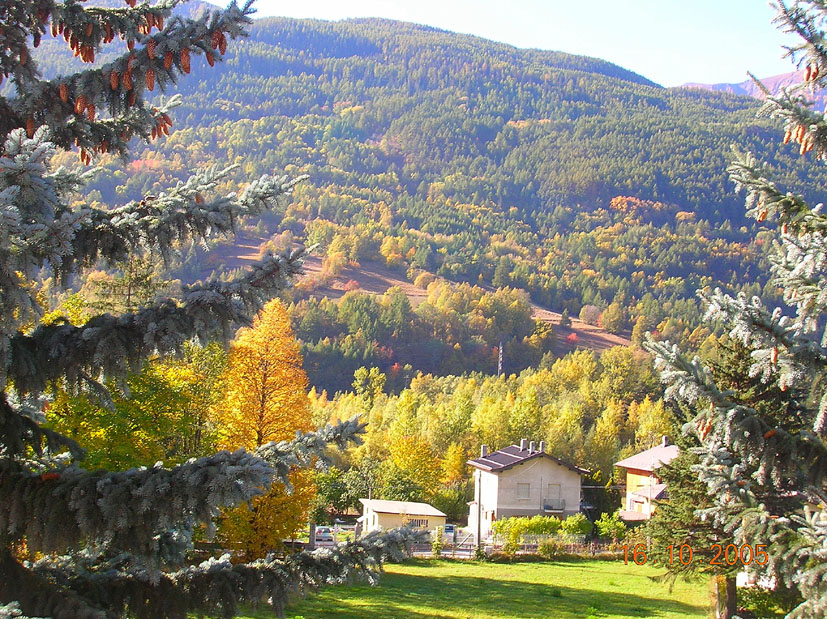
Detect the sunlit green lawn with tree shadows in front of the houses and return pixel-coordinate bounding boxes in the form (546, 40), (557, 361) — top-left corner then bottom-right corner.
(239, 559), (710, 619)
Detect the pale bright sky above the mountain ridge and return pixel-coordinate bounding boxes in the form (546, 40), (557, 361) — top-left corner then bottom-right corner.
(256, 0), (804, 86)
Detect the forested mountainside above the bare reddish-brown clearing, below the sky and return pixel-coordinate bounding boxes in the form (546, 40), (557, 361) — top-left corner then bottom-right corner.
(34, 12), (827, 344)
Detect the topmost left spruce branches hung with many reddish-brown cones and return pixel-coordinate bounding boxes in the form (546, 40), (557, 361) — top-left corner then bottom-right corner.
(0, 0), (254, 157)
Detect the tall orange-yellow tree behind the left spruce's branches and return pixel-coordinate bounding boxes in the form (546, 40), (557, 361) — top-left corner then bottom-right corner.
(219, 300), (316, 561)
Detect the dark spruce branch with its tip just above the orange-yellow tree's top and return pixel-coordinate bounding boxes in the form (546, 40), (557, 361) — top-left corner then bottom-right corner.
(7, 250), (303, 394)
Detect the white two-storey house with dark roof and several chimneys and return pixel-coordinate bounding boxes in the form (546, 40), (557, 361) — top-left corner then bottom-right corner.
(468, 439), (589, 539)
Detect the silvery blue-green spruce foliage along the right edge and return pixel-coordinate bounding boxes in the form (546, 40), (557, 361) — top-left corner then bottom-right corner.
(648, 1), (827, 617)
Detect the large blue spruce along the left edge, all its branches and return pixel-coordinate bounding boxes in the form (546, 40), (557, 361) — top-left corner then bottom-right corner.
(0, 0), (420, 618)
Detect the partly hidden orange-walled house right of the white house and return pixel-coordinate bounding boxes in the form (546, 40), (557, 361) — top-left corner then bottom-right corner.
(615, 436), (680, 522)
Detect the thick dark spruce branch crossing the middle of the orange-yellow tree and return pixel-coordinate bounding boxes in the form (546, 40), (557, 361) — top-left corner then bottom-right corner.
(0, 450), (273, 567)
